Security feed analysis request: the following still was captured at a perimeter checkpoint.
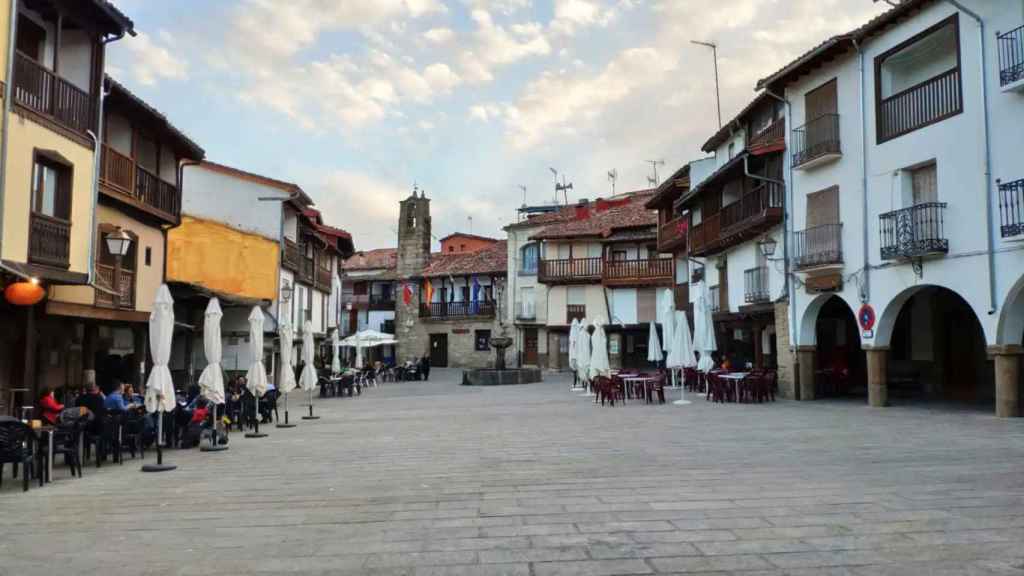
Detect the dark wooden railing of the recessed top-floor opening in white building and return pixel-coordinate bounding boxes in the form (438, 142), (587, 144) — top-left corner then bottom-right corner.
(878, 68), (964, 143)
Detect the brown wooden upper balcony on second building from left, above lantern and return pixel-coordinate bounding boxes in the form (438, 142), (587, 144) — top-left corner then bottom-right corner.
(99, 145), (181, 223)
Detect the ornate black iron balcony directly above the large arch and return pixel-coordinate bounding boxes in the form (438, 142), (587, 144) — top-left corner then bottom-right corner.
(879, 202), (949, 260)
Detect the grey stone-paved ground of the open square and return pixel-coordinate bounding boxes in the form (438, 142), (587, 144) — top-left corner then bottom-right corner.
(6, 370), (1024, 576)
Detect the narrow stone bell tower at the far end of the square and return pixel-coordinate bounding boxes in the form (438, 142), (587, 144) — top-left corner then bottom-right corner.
(394, 189), (431, 362)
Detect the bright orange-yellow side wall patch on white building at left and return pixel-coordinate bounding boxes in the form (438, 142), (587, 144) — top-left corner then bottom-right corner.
(167, 215), (280, 300)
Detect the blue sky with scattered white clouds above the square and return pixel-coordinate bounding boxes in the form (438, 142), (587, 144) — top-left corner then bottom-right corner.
(109, 0), (884, 249)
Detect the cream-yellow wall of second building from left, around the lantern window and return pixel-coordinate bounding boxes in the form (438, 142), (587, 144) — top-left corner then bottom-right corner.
(50, 205), (164, 312)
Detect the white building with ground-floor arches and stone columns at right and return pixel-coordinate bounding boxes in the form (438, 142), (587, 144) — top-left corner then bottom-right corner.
(759, 0), (1024, 416)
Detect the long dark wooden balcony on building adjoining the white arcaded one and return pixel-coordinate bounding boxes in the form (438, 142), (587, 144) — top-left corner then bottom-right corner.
(689, 181), (785, 256)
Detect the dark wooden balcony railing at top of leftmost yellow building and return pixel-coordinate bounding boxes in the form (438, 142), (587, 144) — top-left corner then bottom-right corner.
(14, 52), (96, 135)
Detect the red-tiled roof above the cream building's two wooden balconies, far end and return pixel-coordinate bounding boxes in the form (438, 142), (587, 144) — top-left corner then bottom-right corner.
(530, 190), (657, 240)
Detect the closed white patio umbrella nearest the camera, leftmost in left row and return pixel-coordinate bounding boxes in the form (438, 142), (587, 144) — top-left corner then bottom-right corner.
(142, 284), (177, 472)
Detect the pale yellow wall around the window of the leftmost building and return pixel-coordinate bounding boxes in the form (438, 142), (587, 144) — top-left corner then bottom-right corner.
(0, 114), (93, 274)
